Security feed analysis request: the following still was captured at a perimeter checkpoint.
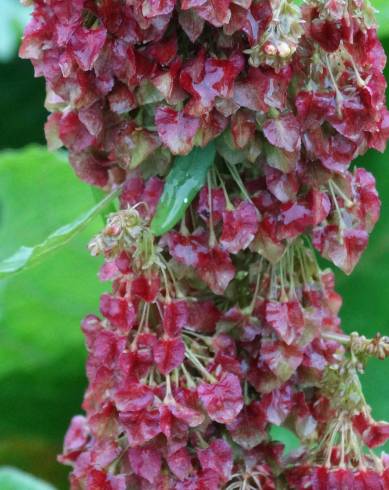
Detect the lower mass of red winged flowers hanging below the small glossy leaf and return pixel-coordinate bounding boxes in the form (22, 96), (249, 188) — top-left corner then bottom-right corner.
(55, 183), (346, 490)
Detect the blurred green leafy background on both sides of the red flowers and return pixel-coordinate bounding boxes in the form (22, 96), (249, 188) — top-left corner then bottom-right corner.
(0, 0), (389, 490)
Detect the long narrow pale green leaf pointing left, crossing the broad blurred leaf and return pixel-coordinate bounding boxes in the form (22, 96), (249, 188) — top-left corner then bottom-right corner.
(0, 190), (118, 279)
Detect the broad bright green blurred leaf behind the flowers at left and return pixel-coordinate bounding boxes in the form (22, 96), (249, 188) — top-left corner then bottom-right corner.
(0, 147), (103, 380)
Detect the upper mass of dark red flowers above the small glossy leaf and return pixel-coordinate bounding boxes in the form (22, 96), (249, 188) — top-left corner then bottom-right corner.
(21, 0), (388, 185)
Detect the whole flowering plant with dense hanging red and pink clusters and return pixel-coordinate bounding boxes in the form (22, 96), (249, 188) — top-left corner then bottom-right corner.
(14, 0), (389, 490)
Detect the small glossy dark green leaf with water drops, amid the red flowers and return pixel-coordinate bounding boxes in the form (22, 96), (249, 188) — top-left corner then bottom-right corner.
(151, 143), (216, 235)
